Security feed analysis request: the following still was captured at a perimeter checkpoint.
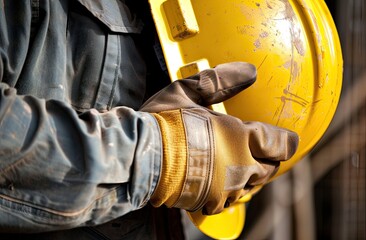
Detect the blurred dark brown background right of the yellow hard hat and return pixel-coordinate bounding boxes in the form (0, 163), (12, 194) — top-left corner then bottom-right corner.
(184, 0), (366, 240)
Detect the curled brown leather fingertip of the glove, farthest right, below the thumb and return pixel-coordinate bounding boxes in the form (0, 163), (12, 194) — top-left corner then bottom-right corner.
(244, 122), (299, 161)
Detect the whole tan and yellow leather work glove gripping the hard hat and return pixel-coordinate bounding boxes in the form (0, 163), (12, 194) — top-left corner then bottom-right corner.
(140, 62), (298, 214)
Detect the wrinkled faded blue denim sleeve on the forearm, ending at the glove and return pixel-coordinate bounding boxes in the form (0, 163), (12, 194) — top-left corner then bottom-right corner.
(0, 82), (161, 232)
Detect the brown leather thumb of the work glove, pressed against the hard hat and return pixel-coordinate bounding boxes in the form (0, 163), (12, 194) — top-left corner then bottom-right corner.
(140, 62), (257, 112)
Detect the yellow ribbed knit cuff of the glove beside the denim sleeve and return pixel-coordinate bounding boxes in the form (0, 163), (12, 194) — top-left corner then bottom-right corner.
(150, 110), (187, 207)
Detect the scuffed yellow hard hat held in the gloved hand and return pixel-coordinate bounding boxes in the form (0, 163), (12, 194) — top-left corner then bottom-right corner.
(150, 0), (343, 239)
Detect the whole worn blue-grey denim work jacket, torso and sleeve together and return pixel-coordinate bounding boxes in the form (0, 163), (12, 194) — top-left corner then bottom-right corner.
(0, 0), (162, 236)
